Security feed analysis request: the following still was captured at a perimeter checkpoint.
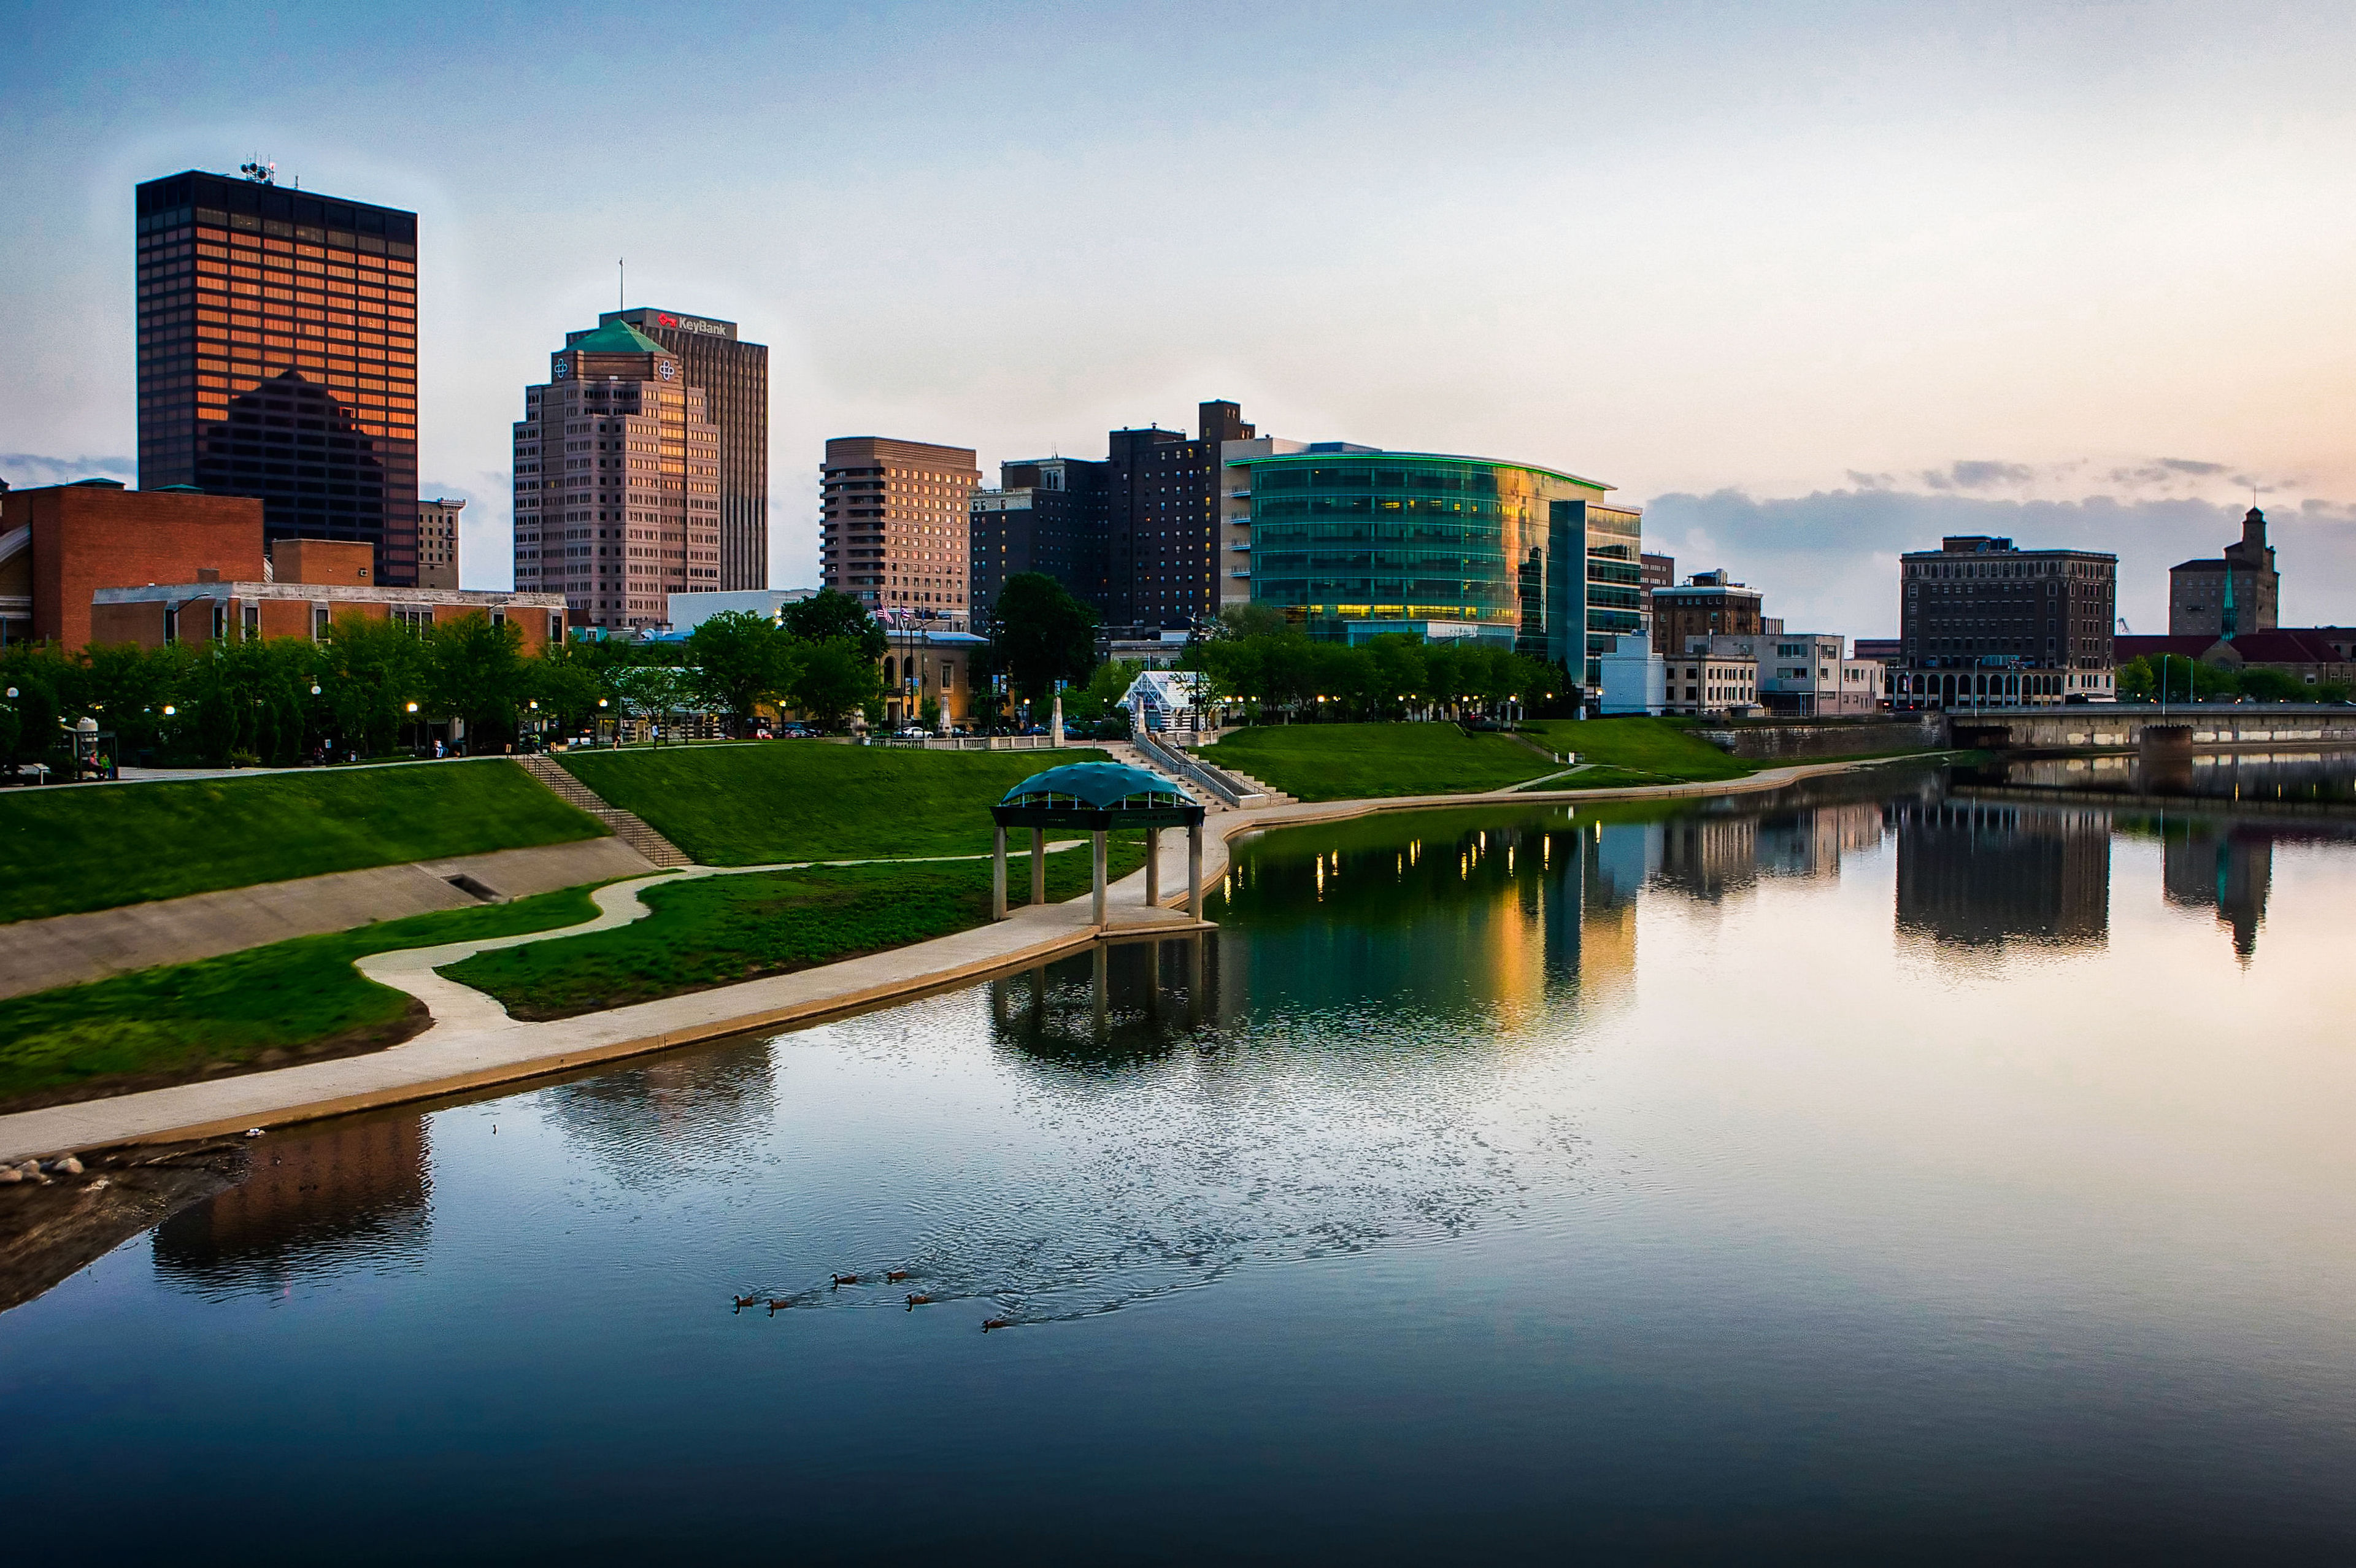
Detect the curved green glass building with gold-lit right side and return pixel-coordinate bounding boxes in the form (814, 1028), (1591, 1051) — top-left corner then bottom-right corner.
(1228, 443), (1644, 685)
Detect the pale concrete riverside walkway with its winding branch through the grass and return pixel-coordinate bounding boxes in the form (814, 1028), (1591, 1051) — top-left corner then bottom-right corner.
(0, 761), (1873, 1161)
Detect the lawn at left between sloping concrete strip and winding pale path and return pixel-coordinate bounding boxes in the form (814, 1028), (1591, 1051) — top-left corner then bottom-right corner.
(0, 885), (596, 1109)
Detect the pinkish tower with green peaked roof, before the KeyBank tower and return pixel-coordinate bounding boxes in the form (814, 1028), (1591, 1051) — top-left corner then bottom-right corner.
(516, 320), (721, 629)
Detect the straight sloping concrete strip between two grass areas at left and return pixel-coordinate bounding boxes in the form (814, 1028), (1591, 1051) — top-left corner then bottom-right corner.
(0, 838), (655, 996)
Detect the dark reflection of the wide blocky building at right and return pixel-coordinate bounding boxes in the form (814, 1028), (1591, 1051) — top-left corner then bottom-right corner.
(1896, 798), (2111, 947)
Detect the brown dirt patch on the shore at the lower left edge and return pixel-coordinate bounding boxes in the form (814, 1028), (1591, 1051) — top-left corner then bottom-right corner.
(0, 1142), (245, 1312)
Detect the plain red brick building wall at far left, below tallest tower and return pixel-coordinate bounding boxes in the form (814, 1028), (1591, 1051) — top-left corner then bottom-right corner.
(0, 485), (261, 647)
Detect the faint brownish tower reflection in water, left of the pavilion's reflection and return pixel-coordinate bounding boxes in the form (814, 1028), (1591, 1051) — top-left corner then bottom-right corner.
(547, 1036), (777, 1182)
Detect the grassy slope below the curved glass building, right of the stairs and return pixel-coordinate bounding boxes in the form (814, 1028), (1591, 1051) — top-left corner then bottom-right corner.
(1204, 723), (1557, 801)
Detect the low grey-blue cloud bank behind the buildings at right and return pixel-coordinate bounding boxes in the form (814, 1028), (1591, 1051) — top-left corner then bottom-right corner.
(1644, 485), (2356, 636)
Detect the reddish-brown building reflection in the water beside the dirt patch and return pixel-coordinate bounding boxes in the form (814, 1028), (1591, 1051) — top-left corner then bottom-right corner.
(155, 1116), (431, 1290)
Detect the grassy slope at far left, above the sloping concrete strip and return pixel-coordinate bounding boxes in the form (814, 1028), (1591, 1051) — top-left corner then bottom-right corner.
(0, 758), (606, 923)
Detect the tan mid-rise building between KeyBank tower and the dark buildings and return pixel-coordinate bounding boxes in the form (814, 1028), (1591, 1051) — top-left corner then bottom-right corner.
(817, 436), (982, 624)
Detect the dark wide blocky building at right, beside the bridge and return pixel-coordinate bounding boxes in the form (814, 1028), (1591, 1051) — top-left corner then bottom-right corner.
(1892, 534), (2118, 706)
